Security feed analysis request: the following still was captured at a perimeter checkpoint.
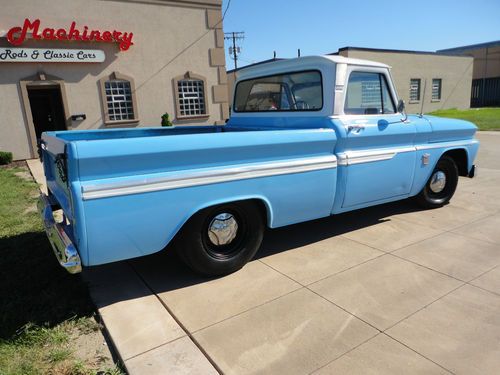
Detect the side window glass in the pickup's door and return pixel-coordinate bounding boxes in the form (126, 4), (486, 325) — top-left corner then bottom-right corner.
(344, 72), (396, 115)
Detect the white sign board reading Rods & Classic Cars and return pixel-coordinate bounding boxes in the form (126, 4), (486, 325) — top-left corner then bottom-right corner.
(0, 47), (106, 63)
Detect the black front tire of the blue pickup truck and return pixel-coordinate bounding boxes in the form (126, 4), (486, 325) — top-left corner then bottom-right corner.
(416, 155), (458, 208)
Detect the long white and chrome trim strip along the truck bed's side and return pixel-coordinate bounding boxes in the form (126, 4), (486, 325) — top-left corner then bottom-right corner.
(82, 155), (337, 200)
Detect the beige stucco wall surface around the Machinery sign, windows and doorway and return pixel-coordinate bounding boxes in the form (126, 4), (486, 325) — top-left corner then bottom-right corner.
(0, 0), (228, 159)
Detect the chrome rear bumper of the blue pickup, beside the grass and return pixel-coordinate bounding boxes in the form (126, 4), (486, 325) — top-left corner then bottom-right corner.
(38, 193), (82, 273)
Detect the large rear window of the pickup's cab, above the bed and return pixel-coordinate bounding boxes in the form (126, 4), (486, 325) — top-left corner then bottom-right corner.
(233, 70), (323, 112)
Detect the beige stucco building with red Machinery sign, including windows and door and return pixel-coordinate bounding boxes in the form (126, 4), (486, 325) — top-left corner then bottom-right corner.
(0, 0), (229, 159)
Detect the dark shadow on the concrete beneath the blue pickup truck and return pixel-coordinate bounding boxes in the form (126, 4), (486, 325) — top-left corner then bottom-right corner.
(91, 201), (426, 306)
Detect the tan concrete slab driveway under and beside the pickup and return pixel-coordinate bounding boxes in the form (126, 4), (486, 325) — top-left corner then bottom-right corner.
(66, 132), (500, 374)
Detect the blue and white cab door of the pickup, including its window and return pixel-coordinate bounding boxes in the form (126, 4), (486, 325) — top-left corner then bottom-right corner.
(341, 67), (416, 207)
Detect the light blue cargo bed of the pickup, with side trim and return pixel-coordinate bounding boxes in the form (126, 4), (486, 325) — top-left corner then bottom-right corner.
(43, 124), (337, 265)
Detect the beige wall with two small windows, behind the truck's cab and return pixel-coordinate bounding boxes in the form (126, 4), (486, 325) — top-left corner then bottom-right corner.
(339, 49), (474, 113)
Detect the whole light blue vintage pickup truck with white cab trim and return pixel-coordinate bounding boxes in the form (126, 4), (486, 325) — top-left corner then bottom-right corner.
(39, 56), (479, 275)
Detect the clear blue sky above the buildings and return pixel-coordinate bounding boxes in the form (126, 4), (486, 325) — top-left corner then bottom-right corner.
(222, 0), (500, 69)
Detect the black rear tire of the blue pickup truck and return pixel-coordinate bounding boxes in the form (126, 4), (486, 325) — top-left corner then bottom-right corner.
(175, 201), (264, 276)
